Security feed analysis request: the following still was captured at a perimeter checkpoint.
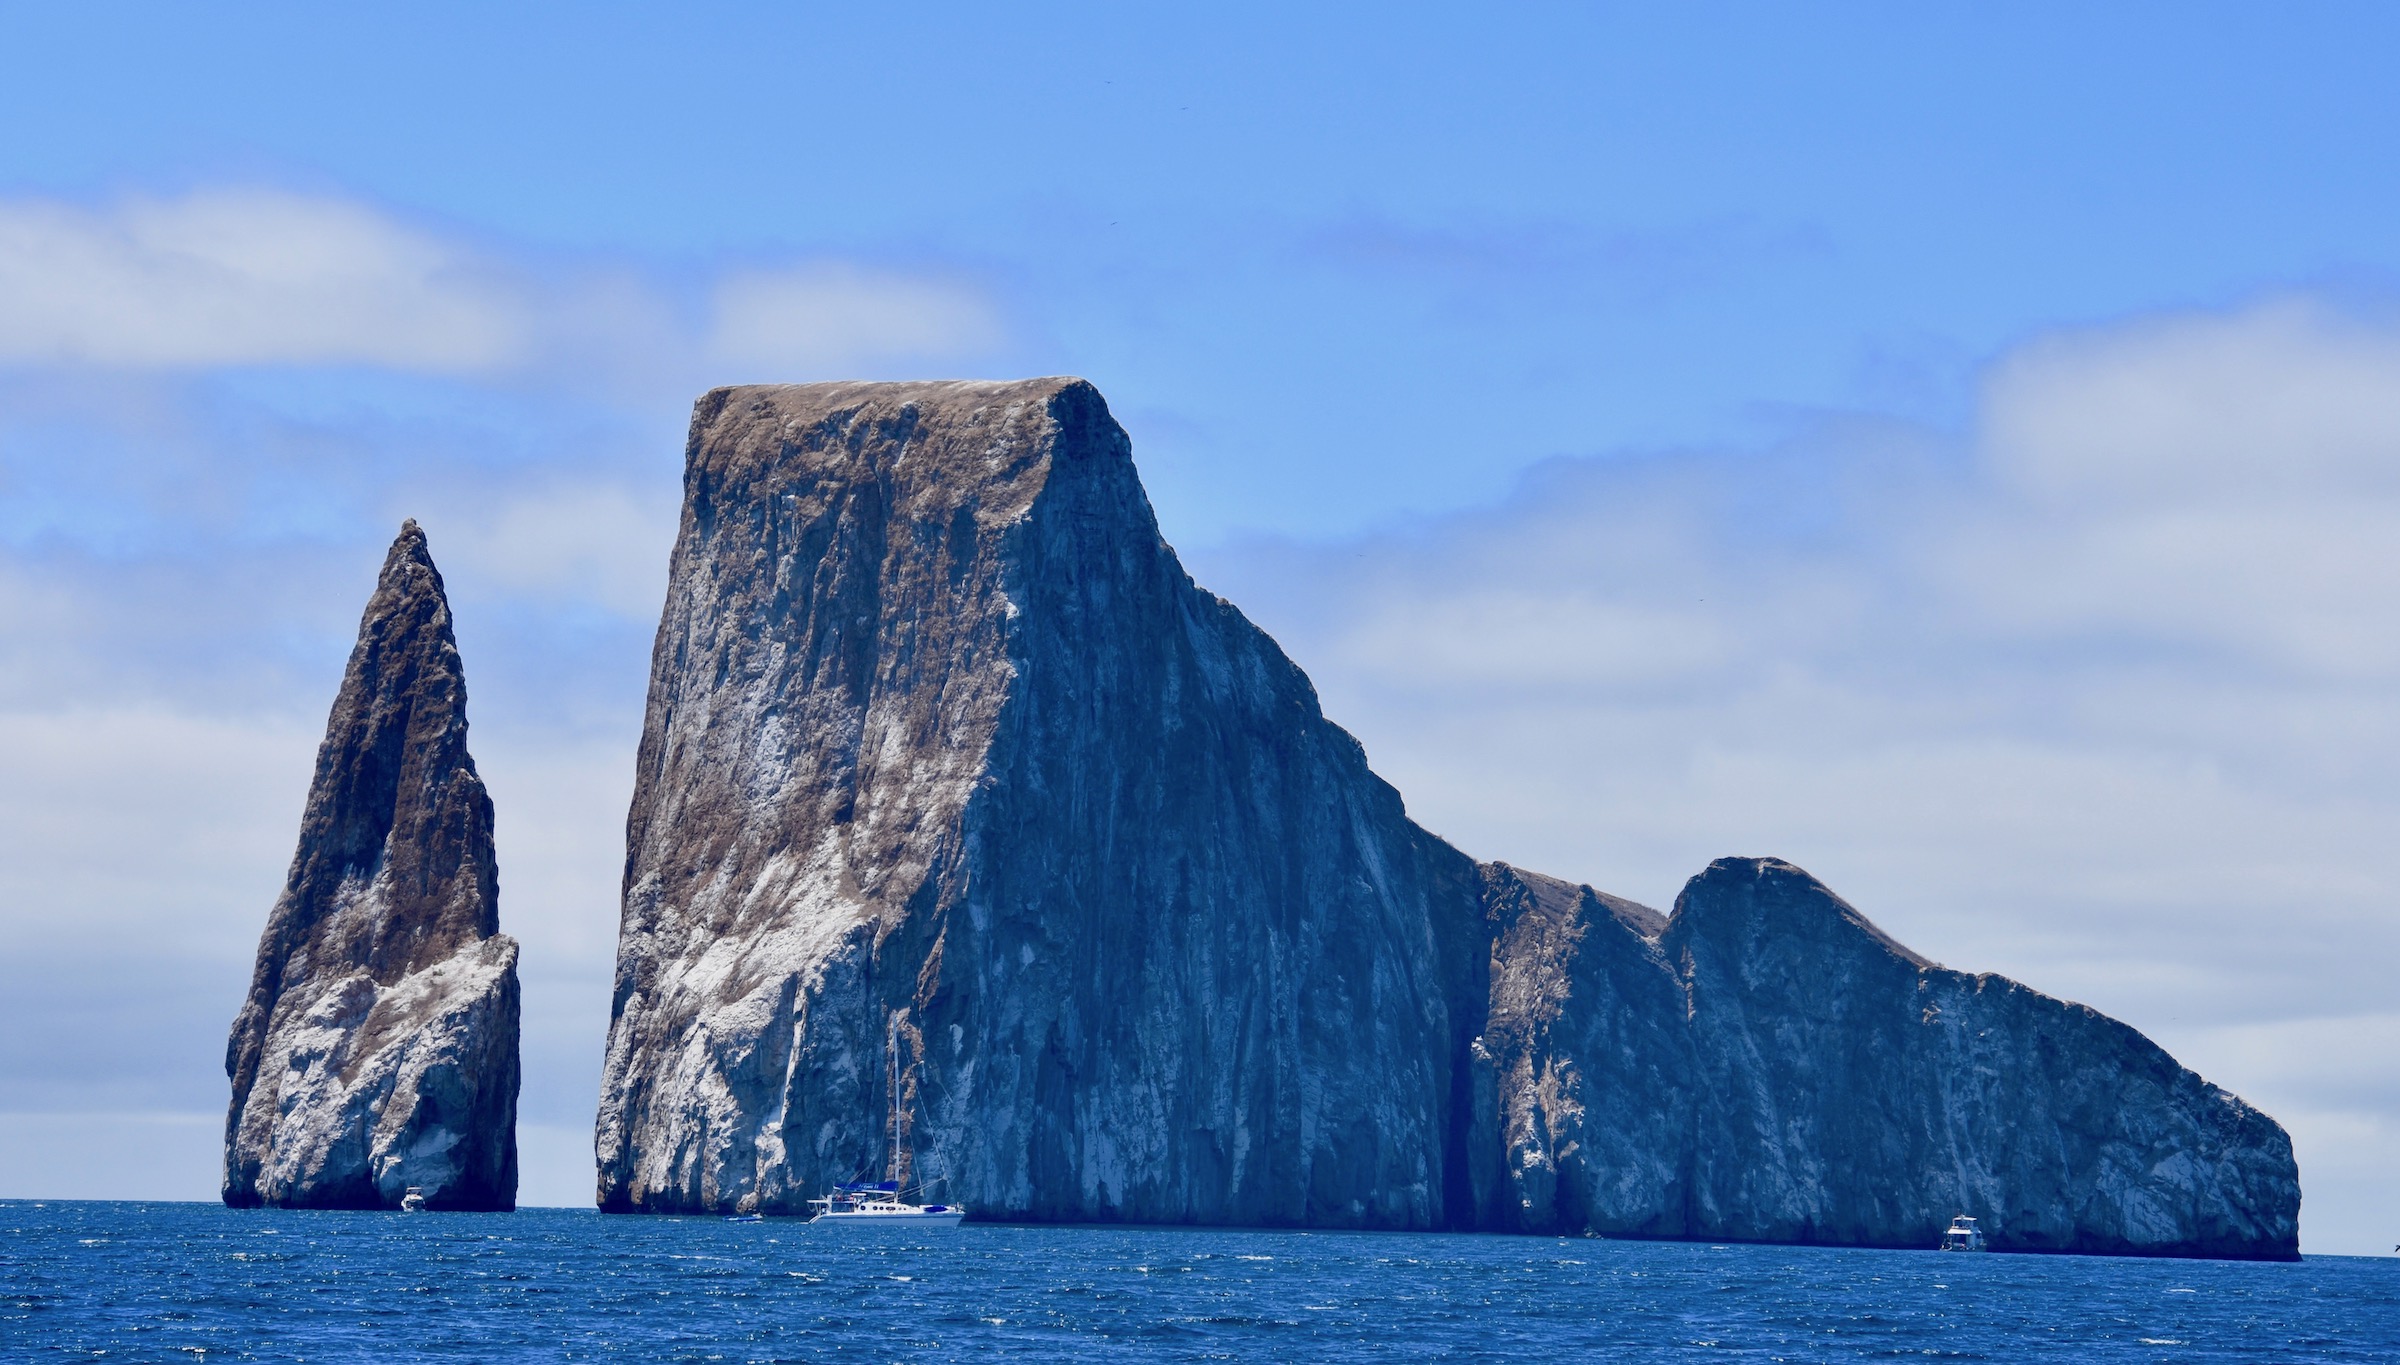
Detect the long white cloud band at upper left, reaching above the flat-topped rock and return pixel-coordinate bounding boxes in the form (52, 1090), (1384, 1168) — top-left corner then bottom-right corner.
(0, 190), (1008, 386)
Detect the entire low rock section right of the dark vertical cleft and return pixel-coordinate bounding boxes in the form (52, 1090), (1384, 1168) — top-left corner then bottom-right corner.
(1483, 859), (2299, 1257)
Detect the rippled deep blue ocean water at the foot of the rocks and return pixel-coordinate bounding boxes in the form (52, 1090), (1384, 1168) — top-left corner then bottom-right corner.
(0, 1199), (2400, 1363)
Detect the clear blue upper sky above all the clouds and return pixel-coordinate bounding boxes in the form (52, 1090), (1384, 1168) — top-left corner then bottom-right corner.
(18, 5), (2395, 535)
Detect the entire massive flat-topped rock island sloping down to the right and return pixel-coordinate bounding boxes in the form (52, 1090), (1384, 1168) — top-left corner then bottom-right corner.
(598, 379), (2297, 1255)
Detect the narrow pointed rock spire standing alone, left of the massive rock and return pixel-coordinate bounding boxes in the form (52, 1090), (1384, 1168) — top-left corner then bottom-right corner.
(226, 521), (518, 1209)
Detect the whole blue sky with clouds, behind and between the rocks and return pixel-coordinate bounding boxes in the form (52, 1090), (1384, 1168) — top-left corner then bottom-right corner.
(0, 5), (2400, 1252)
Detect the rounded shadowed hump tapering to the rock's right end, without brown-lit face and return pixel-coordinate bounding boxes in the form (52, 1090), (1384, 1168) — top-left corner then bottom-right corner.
(1658, 859), (2299, 1255)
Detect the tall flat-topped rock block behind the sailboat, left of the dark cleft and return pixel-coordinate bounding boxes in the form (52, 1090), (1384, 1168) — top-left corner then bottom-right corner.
(598, 379), (1486, 1228)
